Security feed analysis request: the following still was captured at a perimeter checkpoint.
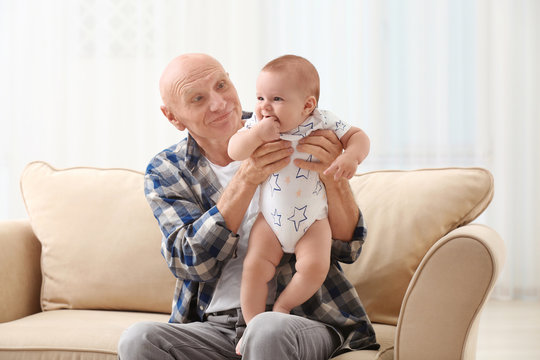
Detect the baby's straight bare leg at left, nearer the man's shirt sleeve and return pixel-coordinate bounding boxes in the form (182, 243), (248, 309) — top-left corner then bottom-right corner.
(240, 214), (283, 324)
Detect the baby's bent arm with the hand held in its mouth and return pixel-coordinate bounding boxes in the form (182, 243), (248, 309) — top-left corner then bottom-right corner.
(227, 117), (279, 160)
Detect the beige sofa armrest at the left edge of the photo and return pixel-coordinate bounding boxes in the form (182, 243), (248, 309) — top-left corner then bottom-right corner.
(0, 220), (41, 323)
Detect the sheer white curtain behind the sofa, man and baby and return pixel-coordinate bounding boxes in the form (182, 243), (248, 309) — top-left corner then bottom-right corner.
(0, 0), (540, 300)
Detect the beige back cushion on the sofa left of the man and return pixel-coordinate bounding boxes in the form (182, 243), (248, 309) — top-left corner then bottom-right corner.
(21, 162), (175, 313)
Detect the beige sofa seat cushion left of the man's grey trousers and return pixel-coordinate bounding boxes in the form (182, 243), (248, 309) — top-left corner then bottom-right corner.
(0, 310), (169, 360)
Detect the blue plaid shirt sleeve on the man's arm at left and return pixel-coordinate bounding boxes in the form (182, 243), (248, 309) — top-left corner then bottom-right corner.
(144, 153), (239, 282)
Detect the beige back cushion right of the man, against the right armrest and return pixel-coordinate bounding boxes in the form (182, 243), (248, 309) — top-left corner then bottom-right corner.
(344, 168), (493, 324)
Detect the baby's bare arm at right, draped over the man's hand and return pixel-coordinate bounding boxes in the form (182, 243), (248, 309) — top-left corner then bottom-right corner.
(324, 126), (369, 180)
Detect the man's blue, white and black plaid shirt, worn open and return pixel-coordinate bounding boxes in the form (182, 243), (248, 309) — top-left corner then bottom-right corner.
(144, 113), (378, 354)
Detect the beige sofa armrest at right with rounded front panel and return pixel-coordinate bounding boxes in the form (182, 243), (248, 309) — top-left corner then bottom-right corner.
(395, 224), (505, 360)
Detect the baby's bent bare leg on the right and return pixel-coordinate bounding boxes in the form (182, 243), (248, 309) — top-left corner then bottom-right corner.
(273, 219), (332, 314)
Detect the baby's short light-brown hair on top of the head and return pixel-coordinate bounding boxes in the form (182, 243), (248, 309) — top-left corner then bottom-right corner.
(261, 55), (320, 102)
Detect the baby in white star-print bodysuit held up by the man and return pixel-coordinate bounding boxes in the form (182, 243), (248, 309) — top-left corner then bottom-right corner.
(228, 55), (369, 334)
